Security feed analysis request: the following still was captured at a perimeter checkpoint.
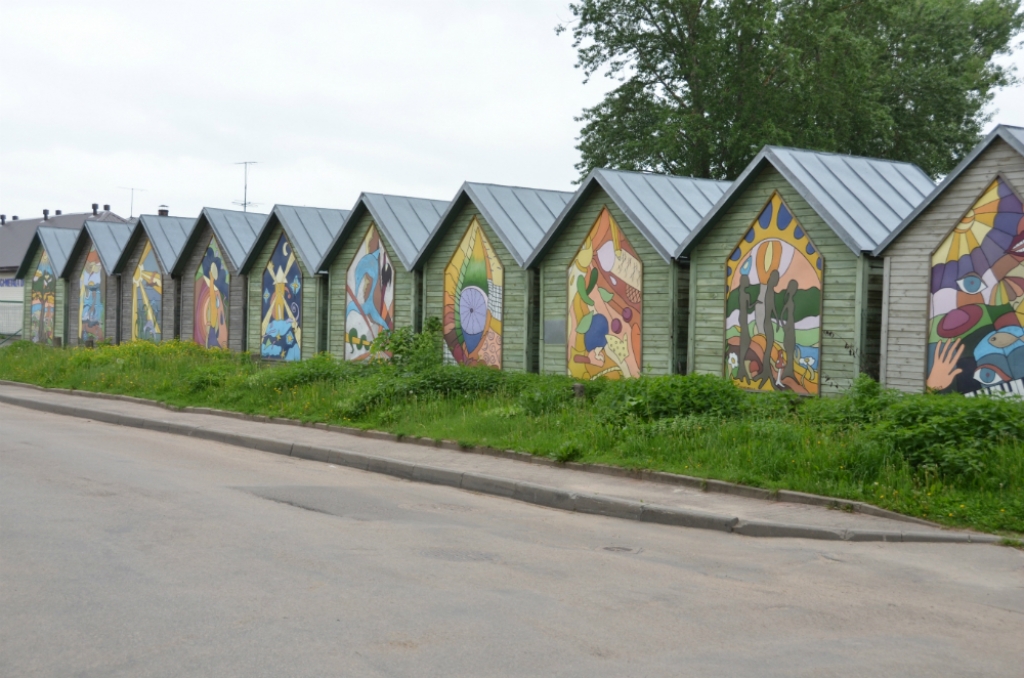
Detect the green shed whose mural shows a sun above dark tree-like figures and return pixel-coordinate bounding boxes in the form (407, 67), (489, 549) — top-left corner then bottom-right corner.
(677, 146), (934, 395)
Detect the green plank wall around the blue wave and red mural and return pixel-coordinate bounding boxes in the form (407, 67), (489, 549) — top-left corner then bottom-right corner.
(328, 212), (416, 358)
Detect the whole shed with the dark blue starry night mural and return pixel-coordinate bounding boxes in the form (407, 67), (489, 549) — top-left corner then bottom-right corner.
(240, 205), (348, 361)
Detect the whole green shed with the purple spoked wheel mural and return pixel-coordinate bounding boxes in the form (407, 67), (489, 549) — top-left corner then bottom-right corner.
(414, 182), (572, 372)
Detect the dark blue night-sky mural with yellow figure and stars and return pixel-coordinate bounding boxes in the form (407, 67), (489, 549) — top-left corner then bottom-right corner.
(260, 235), (302, 361)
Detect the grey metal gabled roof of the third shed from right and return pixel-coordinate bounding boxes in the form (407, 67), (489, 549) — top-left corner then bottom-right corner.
(526, 169), (729, 266)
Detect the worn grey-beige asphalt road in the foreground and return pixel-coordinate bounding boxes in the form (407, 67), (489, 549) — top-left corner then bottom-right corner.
(6, 406), (1024, 678)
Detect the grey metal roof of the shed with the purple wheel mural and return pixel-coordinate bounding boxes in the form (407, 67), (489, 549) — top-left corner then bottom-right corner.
(414, 181), (572, 267)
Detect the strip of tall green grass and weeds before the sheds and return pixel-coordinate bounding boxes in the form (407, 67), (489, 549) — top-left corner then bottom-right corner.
(0, 340), (1024, 535)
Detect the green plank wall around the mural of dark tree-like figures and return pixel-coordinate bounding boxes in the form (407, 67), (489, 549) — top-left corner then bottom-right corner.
(688, 167), (864, 394)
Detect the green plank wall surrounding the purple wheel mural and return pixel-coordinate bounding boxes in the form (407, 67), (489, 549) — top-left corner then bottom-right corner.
(423, 201), (529, 372)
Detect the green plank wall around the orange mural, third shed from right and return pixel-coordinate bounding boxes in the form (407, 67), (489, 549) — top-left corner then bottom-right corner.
(538, 185), (689, 375)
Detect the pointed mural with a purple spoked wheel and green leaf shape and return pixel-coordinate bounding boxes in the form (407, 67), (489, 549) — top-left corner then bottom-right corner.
(442, 217), (505, 369)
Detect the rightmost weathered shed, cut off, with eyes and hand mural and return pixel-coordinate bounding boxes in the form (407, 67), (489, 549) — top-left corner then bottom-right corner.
(874, 125), (1024, 396)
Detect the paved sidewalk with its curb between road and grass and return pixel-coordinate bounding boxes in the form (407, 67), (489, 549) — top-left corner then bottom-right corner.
(0, 384), (997, 543)
